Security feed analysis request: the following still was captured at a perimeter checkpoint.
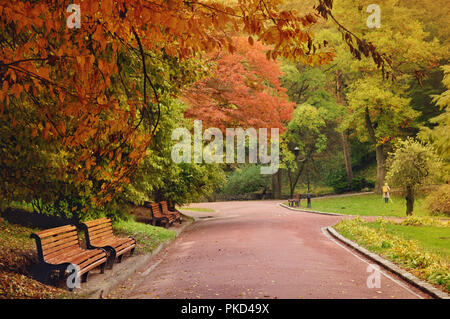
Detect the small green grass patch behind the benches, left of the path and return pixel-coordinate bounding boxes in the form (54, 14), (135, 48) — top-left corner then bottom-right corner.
(113, 219), (177, 254)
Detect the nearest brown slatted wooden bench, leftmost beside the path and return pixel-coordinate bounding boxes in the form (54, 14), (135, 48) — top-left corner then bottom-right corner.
(30, 225), (107, 290)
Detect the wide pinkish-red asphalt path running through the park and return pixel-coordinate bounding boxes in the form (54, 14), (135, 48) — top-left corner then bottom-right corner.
(110, 201), (428, 299)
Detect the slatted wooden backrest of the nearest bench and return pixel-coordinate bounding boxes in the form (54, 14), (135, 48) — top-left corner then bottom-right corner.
(30, 225), (80, 262)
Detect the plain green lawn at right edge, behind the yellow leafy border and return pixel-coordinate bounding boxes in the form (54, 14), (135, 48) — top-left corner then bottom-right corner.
(367, 222), (450, 263)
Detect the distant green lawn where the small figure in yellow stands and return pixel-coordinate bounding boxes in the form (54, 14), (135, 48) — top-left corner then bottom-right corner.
(301, 194), (440, 217)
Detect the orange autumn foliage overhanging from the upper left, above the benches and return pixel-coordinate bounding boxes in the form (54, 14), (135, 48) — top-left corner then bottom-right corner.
(0, 0), (400, 210)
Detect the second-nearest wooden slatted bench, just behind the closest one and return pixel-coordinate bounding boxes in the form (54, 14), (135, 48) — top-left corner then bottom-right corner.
(80, 218), (136, 269)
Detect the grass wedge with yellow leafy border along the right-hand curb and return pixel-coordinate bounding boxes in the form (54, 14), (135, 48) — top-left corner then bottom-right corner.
(334, 217), (450, 292)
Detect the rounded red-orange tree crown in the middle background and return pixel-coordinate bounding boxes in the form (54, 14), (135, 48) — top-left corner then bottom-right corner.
(183, 37), (293, 130)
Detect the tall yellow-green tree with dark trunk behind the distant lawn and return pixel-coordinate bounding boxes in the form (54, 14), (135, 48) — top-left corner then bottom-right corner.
(326, 0), (442, 191)
